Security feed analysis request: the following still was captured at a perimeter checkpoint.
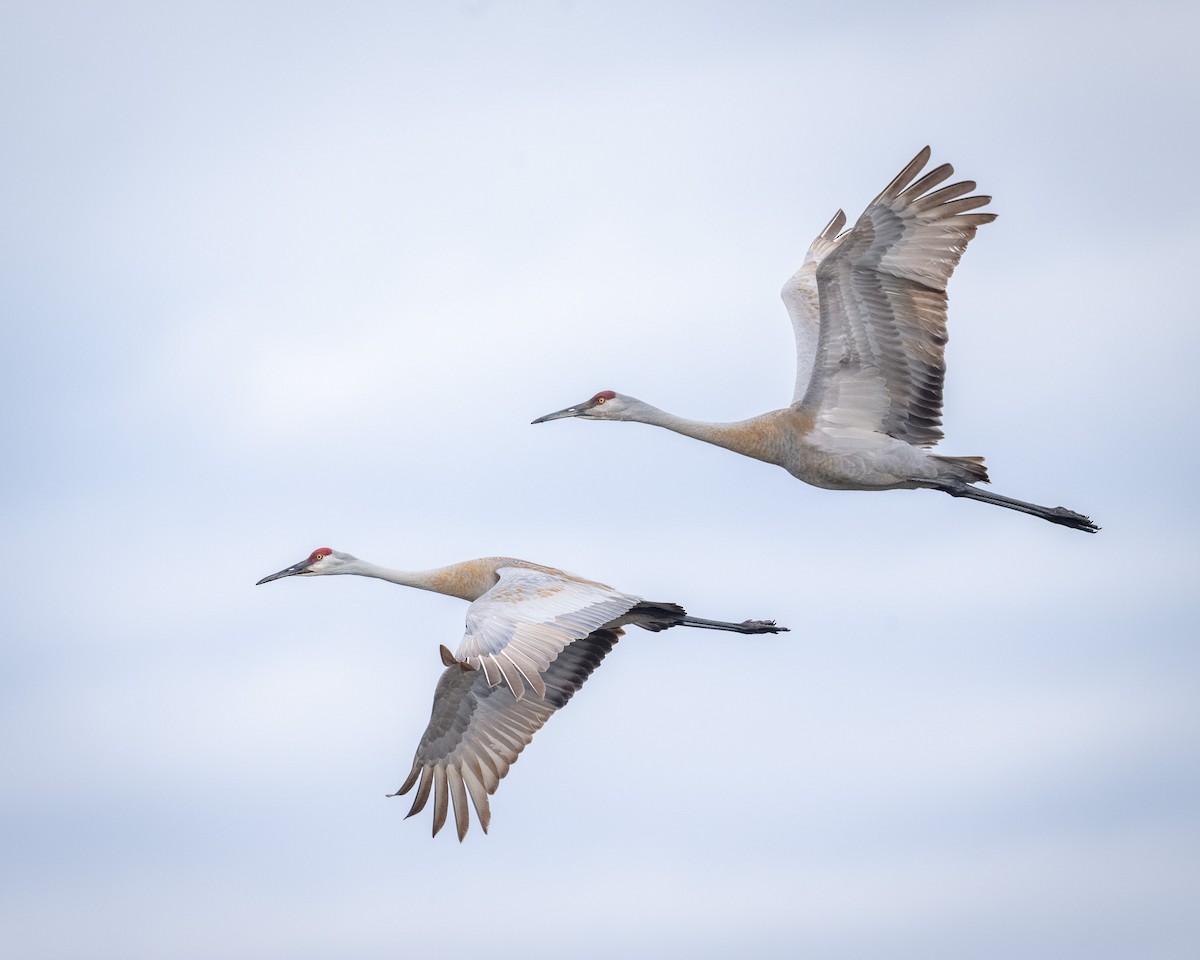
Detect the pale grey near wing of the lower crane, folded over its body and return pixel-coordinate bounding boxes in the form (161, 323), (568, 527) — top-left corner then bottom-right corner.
(456, 566), (641, 700)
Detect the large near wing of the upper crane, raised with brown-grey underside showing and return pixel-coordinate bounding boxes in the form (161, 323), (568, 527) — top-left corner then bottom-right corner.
(798, 146), (996, 446)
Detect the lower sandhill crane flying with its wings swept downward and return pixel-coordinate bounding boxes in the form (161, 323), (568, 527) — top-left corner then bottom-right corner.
(258, 547), (787, 841)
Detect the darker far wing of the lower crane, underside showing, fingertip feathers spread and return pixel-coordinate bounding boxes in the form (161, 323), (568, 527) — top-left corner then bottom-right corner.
(390, 630), (622, 840)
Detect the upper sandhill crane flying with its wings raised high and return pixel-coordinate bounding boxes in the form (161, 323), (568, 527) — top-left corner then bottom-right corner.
(533, 146), (1099, 533)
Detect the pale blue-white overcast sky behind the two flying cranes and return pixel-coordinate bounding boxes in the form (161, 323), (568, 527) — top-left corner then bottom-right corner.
(0, 0), (1200, 960)
